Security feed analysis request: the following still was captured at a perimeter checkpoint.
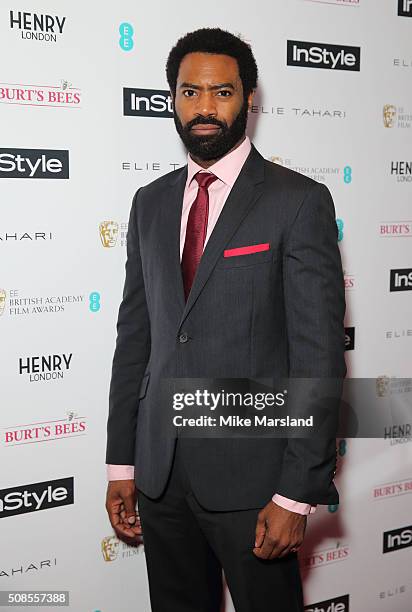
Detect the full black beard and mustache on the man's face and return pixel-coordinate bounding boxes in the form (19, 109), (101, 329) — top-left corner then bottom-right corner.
(173, 100), (248, 161)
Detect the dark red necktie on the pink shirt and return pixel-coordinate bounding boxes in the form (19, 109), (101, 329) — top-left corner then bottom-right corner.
(182, 172), (217, 300)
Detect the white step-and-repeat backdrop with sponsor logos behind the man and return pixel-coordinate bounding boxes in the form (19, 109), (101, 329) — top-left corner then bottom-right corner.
(0, 0), (412, 612)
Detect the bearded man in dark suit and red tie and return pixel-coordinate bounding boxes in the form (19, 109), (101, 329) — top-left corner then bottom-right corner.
(106, 28), (346, 612)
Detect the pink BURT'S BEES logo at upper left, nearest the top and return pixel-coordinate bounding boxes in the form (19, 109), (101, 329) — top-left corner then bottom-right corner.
(0, 79), (81, 108)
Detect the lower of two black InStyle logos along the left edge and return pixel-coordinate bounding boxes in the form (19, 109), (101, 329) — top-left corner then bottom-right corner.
(0, 476), (74, 518)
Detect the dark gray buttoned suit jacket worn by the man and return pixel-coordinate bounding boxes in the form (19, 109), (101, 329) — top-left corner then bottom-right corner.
(106, 146), (346, 510)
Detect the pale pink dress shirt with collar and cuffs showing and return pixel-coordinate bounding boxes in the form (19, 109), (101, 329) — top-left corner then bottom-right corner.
(107, 136), (316, 514)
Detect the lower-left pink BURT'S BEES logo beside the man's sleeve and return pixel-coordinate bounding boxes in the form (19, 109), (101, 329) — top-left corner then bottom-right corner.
(1, 410), (87, 447)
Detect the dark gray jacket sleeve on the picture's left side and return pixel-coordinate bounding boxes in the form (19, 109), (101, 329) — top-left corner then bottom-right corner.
(106, 191), (150, 465)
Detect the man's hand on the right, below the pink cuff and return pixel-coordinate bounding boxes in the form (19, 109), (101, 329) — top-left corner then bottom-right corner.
(253, 500), (307, 559)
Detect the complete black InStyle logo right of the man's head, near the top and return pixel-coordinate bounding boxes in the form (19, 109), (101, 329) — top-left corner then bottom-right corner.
(287, 40), (360, 72)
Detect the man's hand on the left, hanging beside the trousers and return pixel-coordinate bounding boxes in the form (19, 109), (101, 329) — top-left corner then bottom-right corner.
(106, 480), (142, 543)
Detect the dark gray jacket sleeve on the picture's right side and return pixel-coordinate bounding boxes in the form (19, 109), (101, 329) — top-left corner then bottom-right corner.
(276, 183), (346, 505)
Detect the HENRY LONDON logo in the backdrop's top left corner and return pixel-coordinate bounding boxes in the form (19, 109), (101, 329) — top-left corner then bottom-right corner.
(10, 11), (66, 42)
